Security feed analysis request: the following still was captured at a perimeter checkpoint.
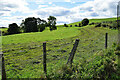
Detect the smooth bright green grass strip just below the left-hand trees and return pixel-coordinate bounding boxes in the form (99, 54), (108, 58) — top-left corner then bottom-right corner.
(2, 27), (78, 44)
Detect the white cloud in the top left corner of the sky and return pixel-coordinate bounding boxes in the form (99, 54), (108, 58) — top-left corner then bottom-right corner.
(0, 0), (29, 15)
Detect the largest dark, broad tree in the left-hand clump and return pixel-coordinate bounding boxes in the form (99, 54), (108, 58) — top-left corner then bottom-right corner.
(24, 17), (38, 32)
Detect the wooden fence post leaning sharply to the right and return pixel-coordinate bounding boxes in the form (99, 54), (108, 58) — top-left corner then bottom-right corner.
(67, 39), (79, 66)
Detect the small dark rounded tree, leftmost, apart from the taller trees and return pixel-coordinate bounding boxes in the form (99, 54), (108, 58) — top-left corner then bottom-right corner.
(8, 23), (20, 34)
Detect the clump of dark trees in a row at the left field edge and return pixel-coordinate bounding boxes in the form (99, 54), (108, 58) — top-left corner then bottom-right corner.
(8, 16), (57, 34)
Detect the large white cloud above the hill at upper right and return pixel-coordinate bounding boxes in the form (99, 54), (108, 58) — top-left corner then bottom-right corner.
(72, 0), (119, 18)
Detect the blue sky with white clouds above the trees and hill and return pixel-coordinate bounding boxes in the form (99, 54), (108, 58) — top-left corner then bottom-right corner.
(0, 0), (119, 27)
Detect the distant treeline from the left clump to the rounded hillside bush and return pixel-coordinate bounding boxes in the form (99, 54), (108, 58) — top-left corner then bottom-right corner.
(2, 16), (89, 36)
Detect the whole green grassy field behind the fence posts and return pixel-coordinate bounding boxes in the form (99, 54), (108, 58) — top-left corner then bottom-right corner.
(2, 18), (117, 78)
